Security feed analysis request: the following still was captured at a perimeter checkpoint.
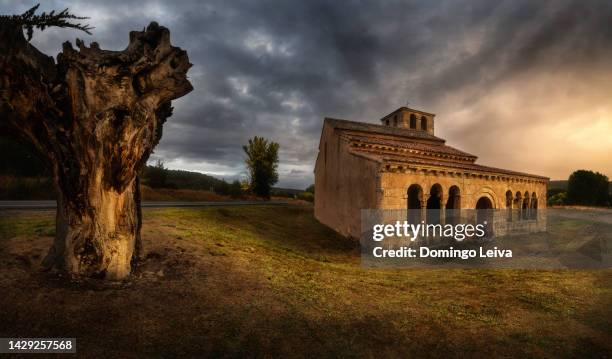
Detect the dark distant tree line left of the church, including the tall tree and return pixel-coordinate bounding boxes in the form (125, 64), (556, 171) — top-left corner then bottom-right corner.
(0, 133), (314, 202)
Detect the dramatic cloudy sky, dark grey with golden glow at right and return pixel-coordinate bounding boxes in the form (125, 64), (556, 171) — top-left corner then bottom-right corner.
(0, 0), (612, 188)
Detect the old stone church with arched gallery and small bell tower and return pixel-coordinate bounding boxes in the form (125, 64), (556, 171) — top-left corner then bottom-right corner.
(314, 107), (548, 238)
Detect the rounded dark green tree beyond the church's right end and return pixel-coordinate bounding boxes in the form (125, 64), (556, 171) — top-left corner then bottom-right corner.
(566, 170), (609, 206)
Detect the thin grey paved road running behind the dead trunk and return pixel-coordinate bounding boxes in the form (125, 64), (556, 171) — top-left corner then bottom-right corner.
(0, 201), (289, 209)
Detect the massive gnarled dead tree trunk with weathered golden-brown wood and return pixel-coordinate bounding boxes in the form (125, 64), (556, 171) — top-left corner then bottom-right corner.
(0, 14), (192, 279)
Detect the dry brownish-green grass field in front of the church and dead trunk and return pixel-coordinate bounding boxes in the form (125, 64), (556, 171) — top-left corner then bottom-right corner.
(0, 206), (612, 358)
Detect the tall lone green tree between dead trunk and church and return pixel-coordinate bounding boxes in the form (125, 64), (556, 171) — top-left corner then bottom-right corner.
(242, 136), (279, 198)
